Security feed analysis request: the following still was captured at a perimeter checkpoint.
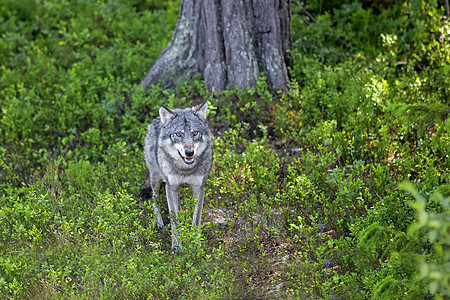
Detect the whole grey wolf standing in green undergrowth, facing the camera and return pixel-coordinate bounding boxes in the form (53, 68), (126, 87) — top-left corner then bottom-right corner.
(142, 101), (213, 252)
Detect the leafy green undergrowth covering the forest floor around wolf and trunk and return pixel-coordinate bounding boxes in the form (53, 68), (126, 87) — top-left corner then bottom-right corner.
(0, 0), (450, 299)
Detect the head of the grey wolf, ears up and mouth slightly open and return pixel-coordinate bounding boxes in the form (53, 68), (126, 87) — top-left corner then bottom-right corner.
(159, 101), (211, 169)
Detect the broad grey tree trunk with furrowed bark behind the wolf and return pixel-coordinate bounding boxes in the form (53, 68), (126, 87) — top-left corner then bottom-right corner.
(140, 0), (292, 91)
